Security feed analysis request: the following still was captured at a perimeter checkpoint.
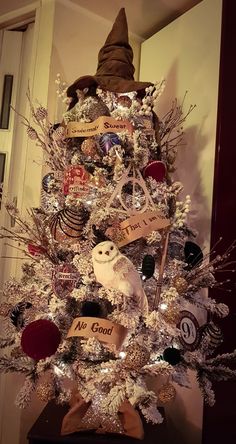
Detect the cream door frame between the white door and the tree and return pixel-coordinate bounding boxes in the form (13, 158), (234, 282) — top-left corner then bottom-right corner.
(0, 0), (55, 444)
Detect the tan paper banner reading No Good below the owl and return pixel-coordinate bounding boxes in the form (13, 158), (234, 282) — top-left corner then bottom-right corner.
(67, 317), (128, 349)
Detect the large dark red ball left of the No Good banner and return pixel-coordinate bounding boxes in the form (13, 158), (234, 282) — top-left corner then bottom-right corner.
(21, 319), (61, 361)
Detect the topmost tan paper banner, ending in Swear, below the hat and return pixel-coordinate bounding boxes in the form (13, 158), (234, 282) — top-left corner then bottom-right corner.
(66, 116), (133, 137)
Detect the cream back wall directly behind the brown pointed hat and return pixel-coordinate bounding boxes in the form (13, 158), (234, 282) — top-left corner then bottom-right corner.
(49, 0), (140, 121)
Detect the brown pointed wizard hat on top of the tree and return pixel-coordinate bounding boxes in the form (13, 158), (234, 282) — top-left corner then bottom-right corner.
(67, 8), (151, 99)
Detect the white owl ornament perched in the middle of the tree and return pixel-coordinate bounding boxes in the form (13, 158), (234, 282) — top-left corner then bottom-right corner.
(92, 241), (148, 316)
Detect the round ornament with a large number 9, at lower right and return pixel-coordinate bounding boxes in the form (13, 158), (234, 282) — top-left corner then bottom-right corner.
(178, 310), (201, 351)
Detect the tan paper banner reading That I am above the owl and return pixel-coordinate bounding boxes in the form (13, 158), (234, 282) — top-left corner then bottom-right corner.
(106, 211), (170, 247)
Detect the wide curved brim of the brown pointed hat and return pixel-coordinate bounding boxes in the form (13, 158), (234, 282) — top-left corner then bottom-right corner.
(67, 76), (152, 97)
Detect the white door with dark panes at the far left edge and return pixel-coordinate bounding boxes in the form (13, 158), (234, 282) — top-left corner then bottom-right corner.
(0, 24), (34, 444)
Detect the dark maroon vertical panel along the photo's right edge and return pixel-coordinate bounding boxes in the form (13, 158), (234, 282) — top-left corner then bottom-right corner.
(202, 0), (236, 444)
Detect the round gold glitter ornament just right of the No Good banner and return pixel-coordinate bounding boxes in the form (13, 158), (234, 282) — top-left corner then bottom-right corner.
(123, 343), (150, 370)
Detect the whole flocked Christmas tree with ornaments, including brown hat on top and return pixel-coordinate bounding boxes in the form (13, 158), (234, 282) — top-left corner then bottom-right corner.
(0, 9), (236, 438)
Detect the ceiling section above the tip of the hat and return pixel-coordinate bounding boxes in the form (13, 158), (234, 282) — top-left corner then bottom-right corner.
(71, 0), (202, 40)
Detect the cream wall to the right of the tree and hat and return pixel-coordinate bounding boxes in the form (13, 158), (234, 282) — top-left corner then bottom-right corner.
(140, 0), (222, 444)
